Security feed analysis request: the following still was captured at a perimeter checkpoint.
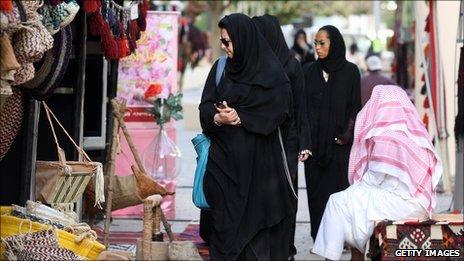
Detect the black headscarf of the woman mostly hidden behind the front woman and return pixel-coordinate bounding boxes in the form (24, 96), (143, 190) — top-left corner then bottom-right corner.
(253, 14), (291, 66)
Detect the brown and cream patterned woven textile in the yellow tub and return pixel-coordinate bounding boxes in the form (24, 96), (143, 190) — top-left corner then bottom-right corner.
(3, 230), (82, 260)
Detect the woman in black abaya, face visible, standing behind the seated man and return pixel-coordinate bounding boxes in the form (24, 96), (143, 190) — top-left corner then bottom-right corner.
(303, 25), (361, 240)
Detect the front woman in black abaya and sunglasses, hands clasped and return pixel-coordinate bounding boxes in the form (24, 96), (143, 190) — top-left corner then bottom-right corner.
(199, 14), (296, 260)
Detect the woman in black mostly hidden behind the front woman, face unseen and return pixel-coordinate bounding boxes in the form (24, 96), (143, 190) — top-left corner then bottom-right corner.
(253, 14), (310, 257)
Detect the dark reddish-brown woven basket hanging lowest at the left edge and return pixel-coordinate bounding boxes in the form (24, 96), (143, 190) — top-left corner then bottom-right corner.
(0, 91), (24, 161)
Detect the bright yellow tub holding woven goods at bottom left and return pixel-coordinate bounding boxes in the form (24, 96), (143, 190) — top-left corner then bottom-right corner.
(0, 207), (105, 260)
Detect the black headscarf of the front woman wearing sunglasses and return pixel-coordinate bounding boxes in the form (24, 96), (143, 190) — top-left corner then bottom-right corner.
(218, 14), (289, 88)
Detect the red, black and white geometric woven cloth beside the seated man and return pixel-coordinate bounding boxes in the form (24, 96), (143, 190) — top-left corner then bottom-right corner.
(368, 217), (464, 260)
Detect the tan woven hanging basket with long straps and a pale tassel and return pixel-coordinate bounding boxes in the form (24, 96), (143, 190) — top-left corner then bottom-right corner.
(36, 102), (105, 205)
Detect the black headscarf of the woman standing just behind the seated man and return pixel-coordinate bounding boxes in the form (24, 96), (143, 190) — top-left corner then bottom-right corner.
(317, 25), (347, 73)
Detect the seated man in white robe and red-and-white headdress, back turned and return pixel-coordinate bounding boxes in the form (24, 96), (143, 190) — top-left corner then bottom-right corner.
(312, 85), (442, 260)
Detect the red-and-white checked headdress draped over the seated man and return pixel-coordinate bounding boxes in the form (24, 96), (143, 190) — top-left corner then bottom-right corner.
(348, 85), (442, 213)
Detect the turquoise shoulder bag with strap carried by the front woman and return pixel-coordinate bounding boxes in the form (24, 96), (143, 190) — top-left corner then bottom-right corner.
(192, 56), (227, 209)
